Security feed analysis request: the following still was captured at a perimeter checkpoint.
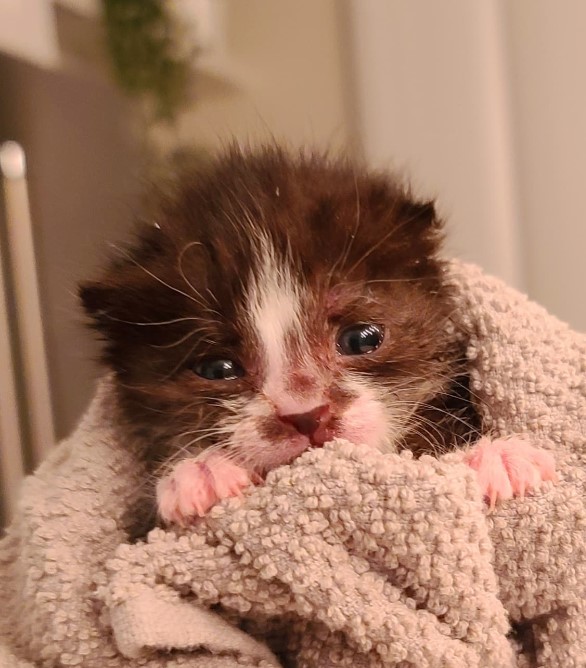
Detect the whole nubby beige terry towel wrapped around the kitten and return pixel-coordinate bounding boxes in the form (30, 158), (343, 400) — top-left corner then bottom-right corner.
(0, 264), (586, 668)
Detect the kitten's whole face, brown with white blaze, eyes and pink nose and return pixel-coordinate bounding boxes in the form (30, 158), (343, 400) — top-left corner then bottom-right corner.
(82, 151), (451, 474)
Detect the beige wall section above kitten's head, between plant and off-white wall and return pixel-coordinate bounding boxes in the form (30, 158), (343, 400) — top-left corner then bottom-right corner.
(157, 0), (352, 153)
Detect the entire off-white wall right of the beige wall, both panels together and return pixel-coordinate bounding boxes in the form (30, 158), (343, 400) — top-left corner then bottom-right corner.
(345, 0), (586, 330)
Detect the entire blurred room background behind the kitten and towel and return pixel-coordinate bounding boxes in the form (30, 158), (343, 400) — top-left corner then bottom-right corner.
(0, 0), (586, 513)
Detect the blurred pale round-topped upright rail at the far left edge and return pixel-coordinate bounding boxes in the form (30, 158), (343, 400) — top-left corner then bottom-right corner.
(0, 142), (55, 523)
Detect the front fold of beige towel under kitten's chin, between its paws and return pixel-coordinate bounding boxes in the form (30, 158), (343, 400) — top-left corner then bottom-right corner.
(105, 441), (514, 668)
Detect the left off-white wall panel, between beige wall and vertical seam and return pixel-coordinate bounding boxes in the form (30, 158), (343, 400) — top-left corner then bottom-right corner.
(347, 0), (524, 287)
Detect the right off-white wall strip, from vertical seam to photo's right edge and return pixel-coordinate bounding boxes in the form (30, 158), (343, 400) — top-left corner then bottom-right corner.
(505, 0), (586, 331)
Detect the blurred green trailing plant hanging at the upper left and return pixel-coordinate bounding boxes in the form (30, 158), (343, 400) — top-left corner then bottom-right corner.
(102, 0), (195, 121)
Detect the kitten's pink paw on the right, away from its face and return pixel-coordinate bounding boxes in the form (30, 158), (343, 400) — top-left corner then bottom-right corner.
(464, 437), (557, 510)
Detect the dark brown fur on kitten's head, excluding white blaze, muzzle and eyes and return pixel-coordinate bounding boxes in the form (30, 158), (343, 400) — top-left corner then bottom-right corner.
(80, 148), (479, 536)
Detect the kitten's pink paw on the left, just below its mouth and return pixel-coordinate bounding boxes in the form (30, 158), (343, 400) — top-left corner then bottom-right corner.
(157, 454), (251, 526)
